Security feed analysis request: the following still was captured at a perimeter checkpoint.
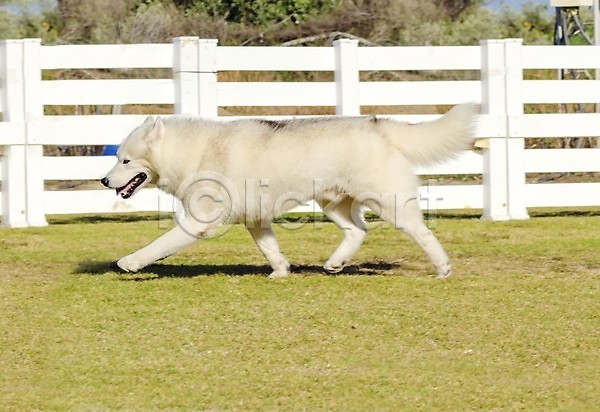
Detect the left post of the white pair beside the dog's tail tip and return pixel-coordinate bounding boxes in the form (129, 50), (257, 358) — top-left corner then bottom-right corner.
(480, 40), (510, 220)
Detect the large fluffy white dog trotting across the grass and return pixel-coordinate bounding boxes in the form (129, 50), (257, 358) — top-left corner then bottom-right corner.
(102, 104), (475, 277)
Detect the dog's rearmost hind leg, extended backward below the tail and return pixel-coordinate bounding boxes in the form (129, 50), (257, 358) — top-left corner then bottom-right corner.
(379, 196), (452, 278)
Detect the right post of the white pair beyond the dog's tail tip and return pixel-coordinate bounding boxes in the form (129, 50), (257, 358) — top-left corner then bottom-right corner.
(504, 39), (529, 220)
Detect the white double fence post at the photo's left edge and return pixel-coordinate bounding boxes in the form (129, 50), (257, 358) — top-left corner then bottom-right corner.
(0, 39), (47, 227)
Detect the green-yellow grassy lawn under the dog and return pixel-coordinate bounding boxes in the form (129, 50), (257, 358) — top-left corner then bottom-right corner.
(0, 211), (600, 411)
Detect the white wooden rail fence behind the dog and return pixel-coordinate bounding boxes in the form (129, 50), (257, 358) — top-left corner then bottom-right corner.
(0, 37), (600, 227)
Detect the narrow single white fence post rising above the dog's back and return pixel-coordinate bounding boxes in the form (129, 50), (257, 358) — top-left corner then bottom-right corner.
(333, 39), (360, 116)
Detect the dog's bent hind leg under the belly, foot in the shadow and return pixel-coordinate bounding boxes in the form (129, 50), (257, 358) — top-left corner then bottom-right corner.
(319, 196), (367, 273)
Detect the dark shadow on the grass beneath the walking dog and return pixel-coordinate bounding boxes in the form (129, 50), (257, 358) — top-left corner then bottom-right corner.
(73, 261), (401, 281)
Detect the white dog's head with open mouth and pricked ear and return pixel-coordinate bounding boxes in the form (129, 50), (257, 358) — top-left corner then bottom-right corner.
(101, 116), (164, 199)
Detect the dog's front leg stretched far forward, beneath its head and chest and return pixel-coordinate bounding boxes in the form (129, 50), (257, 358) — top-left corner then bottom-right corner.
(117, 219), (207, 272)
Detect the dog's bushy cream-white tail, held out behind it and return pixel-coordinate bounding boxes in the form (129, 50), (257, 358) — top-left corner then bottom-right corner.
(390, 103), (478, 166)
